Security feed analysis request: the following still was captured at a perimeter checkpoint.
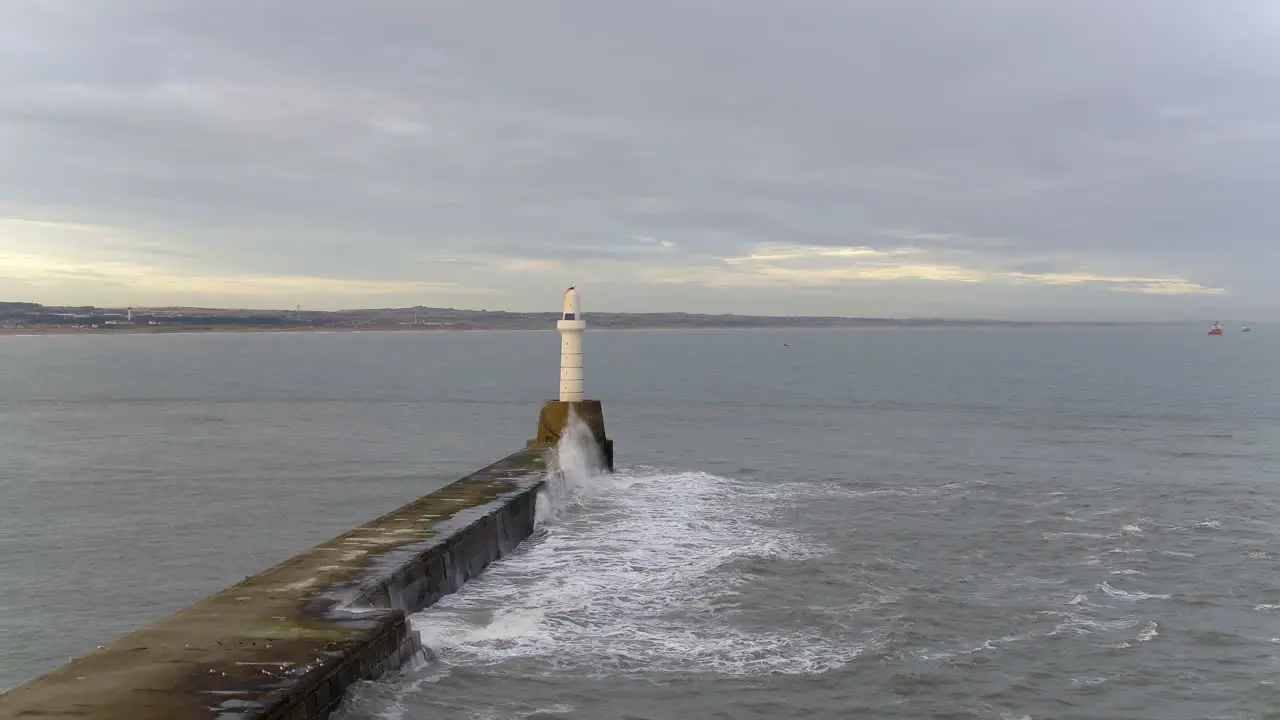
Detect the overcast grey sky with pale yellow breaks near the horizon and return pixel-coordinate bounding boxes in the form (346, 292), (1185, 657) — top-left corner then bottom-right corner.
(0, 0), (1280, 320)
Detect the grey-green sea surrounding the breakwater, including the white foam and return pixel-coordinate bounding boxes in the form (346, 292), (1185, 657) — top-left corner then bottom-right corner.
(0, 325), (1280, 720)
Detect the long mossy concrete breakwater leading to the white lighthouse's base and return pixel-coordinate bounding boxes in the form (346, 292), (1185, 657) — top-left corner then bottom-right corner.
(0, 447), (547, 720)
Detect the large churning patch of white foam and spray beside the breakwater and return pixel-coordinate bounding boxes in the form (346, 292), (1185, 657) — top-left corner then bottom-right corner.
(412, 412), (849, 676)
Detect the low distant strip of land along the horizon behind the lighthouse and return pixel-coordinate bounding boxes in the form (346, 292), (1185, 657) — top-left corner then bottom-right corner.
(0, 302), (1185, 336)
